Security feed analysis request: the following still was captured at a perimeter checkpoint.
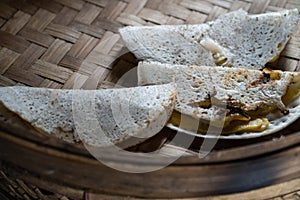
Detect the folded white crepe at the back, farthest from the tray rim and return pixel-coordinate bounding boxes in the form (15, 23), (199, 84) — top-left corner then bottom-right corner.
(120, 9), (299, 69)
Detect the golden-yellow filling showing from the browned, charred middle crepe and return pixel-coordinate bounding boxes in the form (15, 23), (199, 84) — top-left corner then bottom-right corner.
(170, 69), (300, 135)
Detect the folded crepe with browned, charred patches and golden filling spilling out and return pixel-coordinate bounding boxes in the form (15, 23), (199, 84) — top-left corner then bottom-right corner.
(138, 62), (300, 138)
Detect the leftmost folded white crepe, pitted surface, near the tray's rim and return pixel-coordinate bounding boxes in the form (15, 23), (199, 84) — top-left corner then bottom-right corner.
(0, 84), (176, 148)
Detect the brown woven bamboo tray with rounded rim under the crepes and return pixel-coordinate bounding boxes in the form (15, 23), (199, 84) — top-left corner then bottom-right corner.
(0, 0), (300, 200)
